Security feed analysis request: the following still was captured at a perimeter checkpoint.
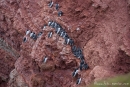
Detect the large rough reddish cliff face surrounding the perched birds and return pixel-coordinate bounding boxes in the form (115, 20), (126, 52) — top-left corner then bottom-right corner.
(0, 0), (130, 87)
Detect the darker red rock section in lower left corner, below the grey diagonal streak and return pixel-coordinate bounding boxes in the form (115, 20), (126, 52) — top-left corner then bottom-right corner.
(0, 49), (16, 87)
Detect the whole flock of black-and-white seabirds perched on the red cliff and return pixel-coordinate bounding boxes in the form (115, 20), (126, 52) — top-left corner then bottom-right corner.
(23, 1), (89, 84)
